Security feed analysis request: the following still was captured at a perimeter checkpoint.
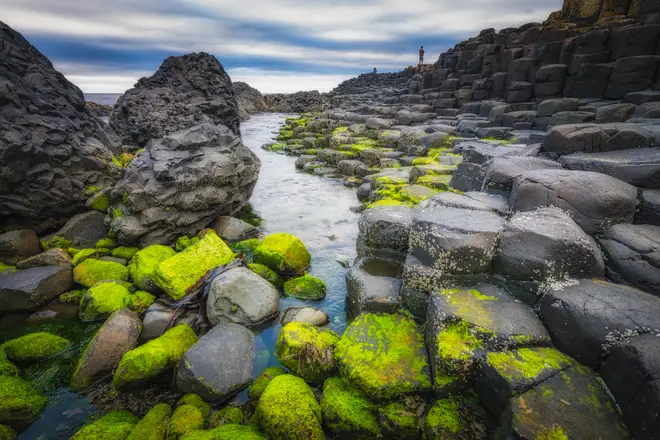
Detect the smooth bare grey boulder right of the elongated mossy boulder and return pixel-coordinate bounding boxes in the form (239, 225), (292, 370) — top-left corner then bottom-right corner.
(176, 323), (255, 402)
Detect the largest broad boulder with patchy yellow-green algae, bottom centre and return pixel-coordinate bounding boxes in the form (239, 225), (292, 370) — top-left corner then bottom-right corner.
(335, 313), (431, 399)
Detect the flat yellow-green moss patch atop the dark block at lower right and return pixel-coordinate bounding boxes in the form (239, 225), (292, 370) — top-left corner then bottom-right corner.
(486, 348), (573, 381)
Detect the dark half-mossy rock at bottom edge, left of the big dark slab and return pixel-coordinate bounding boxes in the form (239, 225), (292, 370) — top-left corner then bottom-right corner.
(425, 391), (490, 440)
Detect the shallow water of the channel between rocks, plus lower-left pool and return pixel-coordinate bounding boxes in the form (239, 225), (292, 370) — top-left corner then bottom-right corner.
(5, 114), (359, 440)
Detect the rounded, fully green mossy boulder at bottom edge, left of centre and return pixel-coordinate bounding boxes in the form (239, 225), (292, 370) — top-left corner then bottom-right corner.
(257, 374), (325, 440)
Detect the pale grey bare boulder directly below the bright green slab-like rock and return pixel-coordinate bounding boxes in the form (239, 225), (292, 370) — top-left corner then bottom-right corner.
(206, 267), (280, 327)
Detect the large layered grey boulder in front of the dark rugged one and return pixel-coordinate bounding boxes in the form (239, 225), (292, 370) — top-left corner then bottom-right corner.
(109, 123), (261, 245)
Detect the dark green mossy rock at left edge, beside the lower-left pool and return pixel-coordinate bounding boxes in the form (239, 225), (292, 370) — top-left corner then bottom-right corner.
(0, 376), (48, 428)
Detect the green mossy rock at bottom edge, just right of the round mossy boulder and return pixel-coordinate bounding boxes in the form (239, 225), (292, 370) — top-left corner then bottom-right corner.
(321, 377), (382, 440)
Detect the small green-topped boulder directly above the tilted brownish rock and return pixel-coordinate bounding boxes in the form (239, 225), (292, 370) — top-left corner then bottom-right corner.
(79, 281), (133, 322)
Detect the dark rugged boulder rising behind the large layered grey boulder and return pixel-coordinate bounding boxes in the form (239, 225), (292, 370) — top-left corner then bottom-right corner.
(110, 52), (240, 146)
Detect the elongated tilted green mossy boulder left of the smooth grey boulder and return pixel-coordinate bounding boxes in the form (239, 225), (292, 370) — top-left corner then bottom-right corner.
(112, 324), (197, 390)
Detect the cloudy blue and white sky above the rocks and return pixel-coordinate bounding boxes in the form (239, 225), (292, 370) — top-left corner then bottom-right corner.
(0, 0), (562, 93)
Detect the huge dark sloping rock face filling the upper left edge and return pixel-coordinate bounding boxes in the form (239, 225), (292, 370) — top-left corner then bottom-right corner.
(0, 22), (121, 232)
